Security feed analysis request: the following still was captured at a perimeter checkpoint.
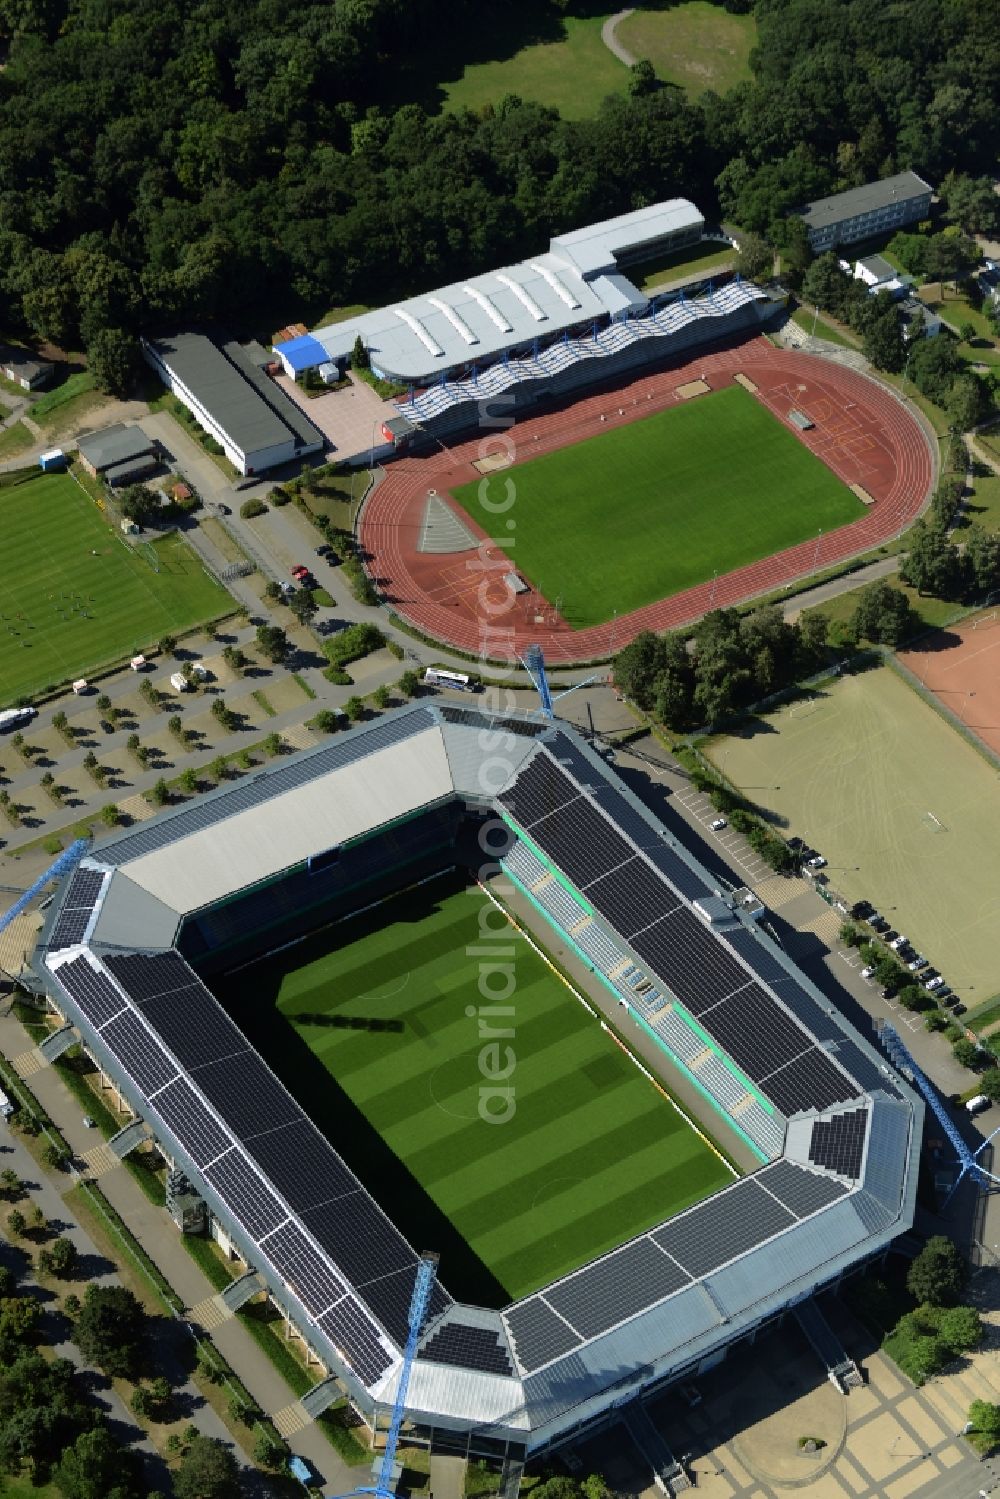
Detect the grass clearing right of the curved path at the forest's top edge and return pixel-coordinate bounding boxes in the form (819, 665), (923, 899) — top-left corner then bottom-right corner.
(615, 0), (757, 97)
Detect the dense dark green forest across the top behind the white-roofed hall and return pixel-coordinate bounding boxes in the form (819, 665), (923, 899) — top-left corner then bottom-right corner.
(0, 0), (1000, 366)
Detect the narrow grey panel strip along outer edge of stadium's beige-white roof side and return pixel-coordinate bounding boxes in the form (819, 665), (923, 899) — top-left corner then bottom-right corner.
(100, 708), (435, 883)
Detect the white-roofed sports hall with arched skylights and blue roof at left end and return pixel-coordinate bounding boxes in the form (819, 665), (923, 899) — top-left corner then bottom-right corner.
(284, 198), (705, 385)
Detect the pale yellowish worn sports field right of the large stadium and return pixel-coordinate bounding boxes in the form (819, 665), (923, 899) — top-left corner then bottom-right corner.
(709, 666), (1000, 1007)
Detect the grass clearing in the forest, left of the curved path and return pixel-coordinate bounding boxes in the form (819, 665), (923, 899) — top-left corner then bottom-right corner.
(442, 7), (626, 120)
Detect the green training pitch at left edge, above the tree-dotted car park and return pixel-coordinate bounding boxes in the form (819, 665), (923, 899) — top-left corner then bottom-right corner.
(0, 474), (232, 703)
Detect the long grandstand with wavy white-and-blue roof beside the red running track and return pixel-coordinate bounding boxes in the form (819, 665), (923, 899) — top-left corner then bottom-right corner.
(397, 280), (766, 432)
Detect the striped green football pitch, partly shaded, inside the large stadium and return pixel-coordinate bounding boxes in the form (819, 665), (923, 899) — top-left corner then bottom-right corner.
(217, 878), (733, 1306)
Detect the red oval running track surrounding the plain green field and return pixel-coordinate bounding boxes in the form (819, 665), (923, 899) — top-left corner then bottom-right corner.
(358, 337), (934, 664)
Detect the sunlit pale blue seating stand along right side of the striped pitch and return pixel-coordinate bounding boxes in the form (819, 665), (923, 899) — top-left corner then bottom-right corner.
(501, 838), (784, 1160)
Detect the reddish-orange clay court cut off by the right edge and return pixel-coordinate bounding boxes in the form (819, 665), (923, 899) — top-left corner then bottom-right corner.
(900, 609), (1000, 755)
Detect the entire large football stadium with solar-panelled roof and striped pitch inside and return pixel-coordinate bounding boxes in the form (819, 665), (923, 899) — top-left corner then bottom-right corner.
(31, 702), (922, 1475)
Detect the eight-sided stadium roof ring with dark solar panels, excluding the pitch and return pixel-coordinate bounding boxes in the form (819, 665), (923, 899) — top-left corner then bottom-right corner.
(33, 703), (922, 1451)
